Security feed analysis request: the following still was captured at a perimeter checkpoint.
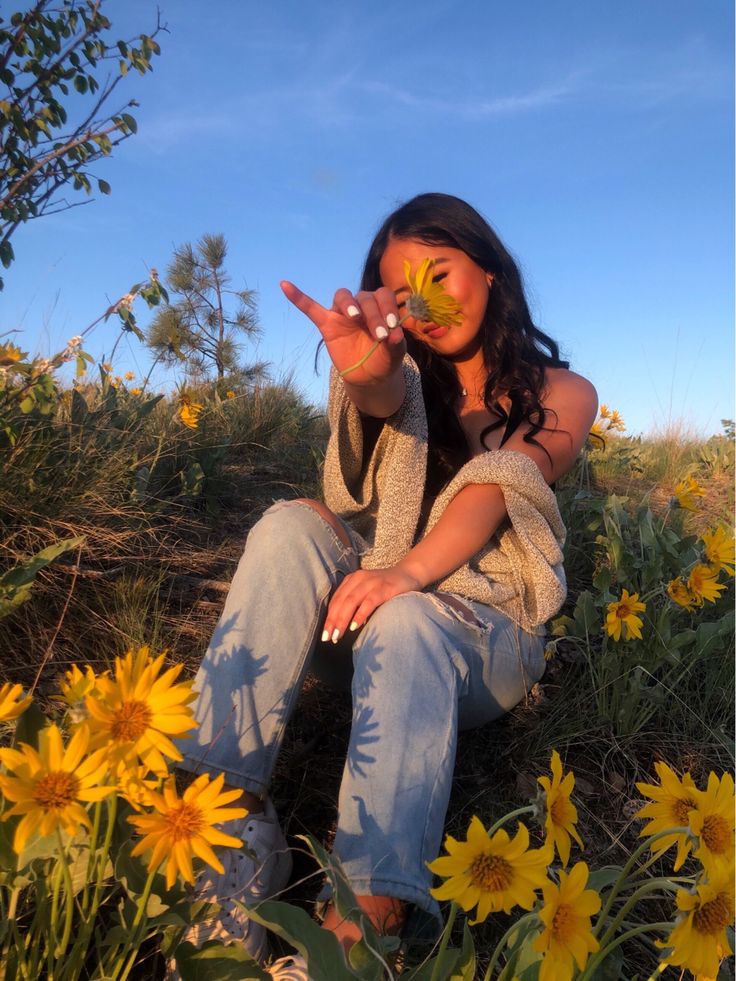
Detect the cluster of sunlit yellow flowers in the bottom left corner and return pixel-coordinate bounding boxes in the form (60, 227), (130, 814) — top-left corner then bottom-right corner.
(0, 647), (247, 886)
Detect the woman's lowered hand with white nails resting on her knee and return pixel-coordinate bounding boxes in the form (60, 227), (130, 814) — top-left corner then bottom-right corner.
(322, 566), (422, 644)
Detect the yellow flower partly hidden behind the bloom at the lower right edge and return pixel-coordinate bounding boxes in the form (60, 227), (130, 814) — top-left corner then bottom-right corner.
(636, 763), (699, 872)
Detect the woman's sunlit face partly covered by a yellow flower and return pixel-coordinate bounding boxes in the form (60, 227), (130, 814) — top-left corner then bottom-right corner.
(379, 238), (493, 360)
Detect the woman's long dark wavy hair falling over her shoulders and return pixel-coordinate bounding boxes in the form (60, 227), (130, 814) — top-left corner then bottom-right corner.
(361, 194), (569, 496)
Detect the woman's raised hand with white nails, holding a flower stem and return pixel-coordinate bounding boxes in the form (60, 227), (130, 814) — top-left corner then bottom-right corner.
(281, 280), (406, 386)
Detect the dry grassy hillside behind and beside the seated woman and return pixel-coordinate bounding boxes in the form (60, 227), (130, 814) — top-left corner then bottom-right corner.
(0, 359), (734, 978)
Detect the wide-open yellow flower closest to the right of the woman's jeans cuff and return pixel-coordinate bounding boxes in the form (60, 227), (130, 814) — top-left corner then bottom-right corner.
(427, 817), (554, 924)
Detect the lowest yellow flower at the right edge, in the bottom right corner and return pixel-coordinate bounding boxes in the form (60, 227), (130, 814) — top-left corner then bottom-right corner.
(658, 866), (734, 981)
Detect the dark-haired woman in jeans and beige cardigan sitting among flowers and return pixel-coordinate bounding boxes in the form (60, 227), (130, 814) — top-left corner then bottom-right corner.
(172, 188), (597, 979)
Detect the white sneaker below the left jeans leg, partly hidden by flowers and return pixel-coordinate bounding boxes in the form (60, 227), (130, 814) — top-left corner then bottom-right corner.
(166, 799), (292, 968)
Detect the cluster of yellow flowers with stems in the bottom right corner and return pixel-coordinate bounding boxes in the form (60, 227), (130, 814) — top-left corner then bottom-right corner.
(429, 751), (734, 981)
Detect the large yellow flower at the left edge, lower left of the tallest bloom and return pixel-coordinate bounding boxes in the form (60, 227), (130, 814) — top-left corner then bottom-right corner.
(0, 725), (115, 854)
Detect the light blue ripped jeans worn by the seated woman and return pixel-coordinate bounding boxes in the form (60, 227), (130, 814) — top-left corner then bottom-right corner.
(179, 501), (545, 915)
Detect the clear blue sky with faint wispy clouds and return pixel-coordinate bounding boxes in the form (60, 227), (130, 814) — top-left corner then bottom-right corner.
(0, 0), (734, 433)
